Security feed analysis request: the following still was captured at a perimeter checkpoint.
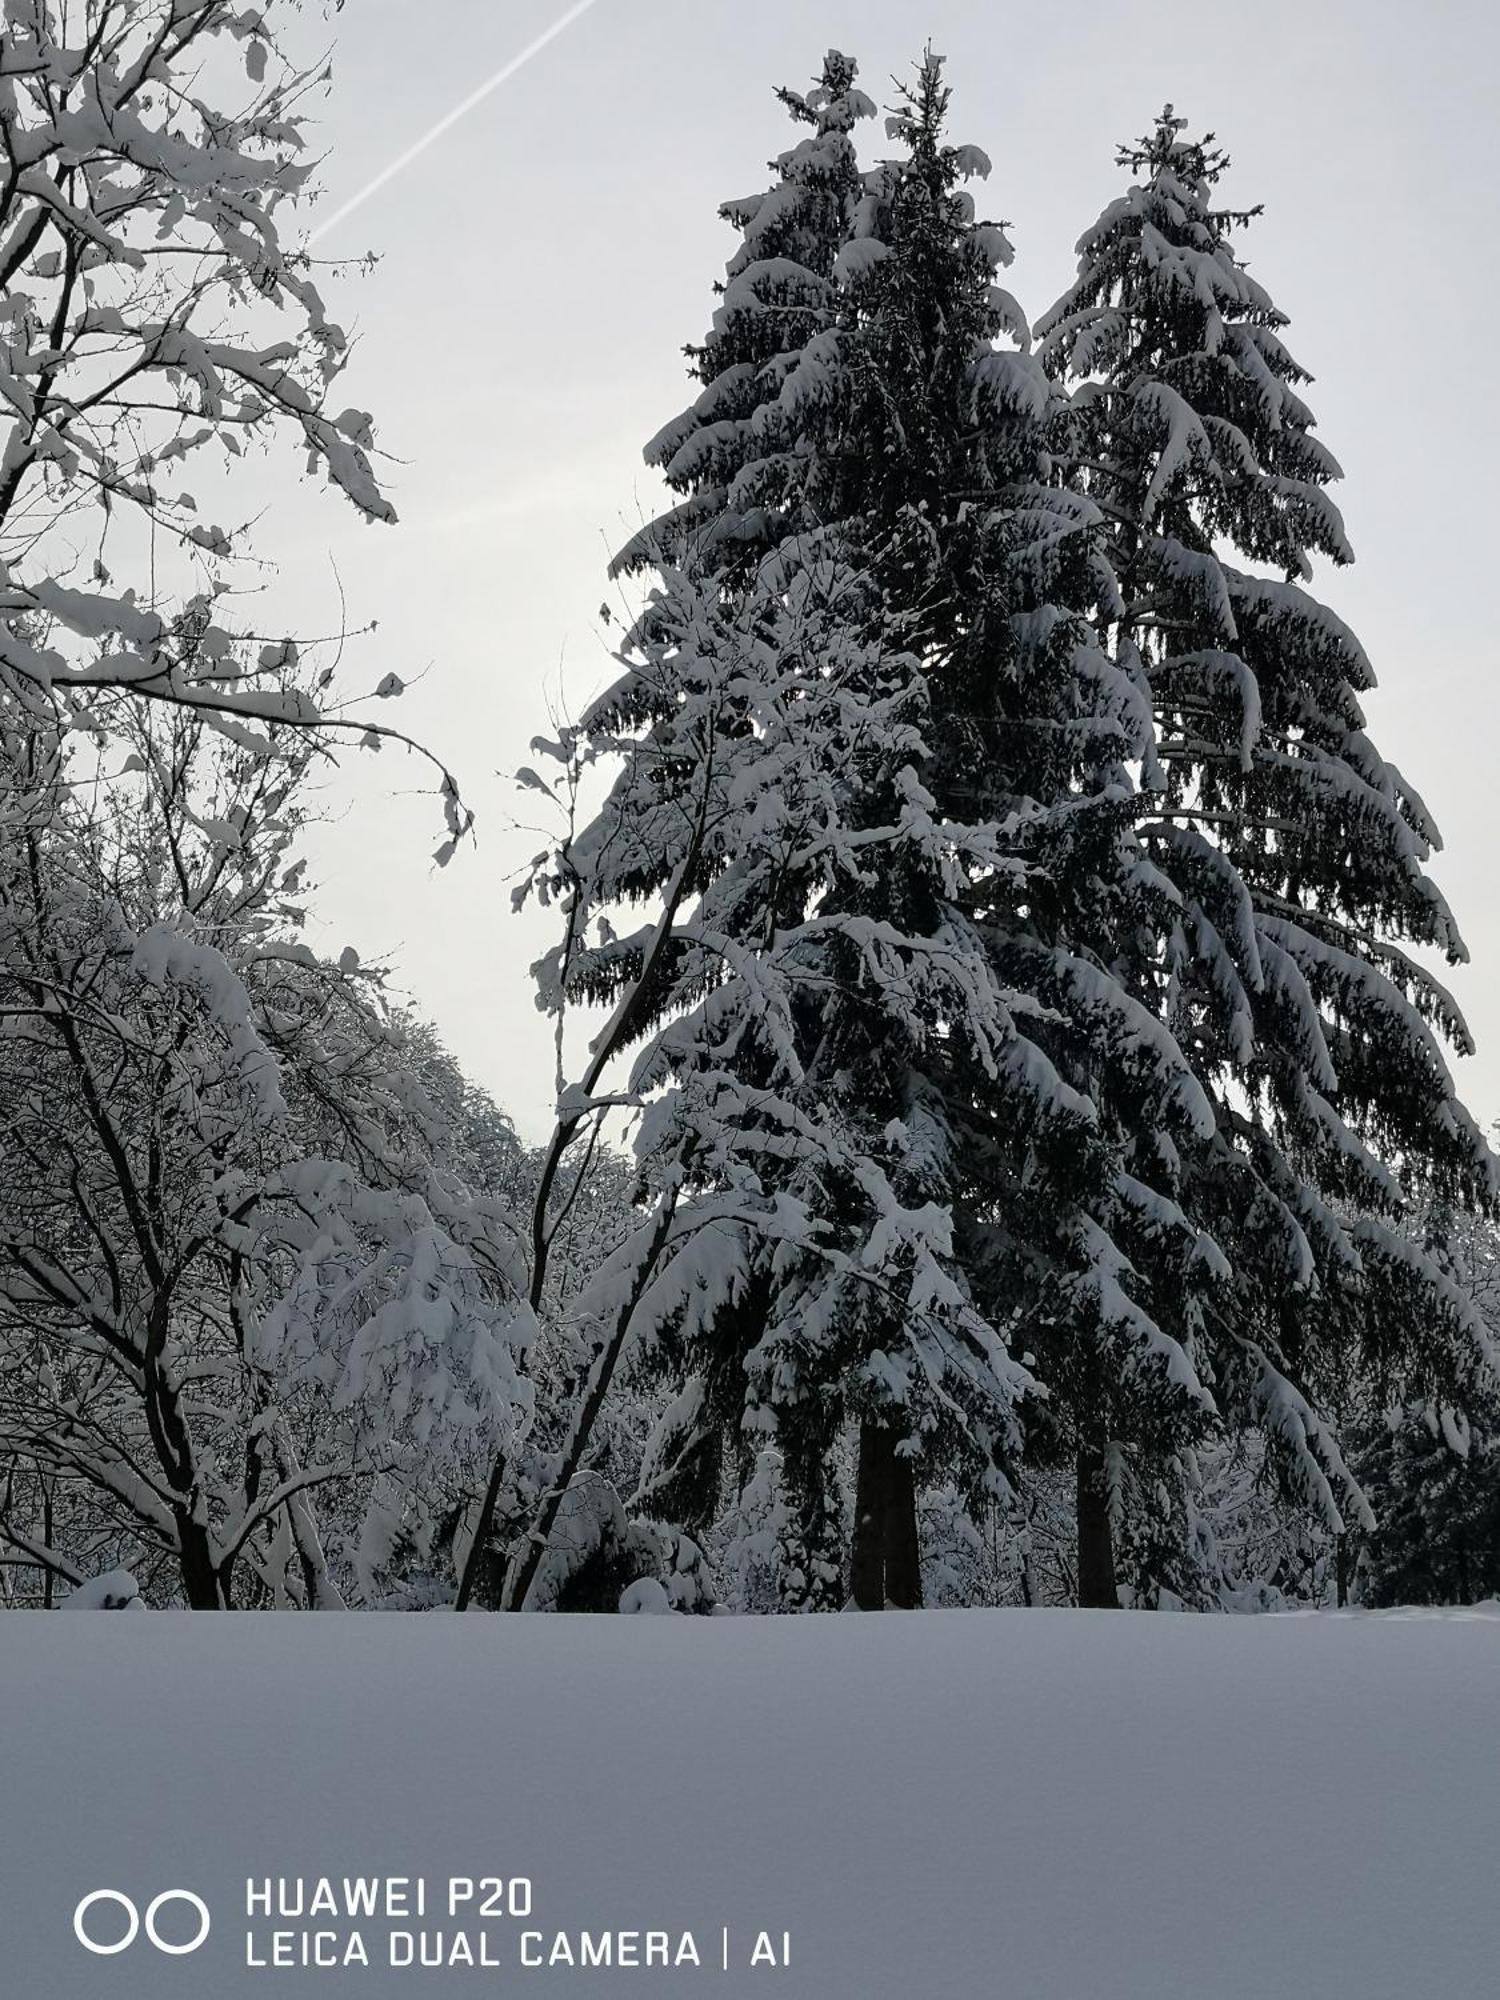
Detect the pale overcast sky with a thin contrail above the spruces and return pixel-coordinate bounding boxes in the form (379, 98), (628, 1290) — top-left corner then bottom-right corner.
(262, 0), (1500, 1136)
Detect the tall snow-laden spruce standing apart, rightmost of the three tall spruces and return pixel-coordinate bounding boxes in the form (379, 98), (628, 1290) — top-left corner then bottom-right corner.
(1038, 106), (1492, 1608)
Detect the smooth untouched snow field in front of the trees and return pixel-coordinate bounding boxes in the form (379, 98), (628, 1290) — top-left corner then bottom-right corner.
(0, 1608), (1500, 2000)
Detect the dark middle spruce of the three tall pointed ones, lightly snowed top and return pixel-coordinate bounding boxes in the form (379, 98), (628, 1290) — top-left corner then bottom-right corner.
(592, 56), (1220, 1602)
